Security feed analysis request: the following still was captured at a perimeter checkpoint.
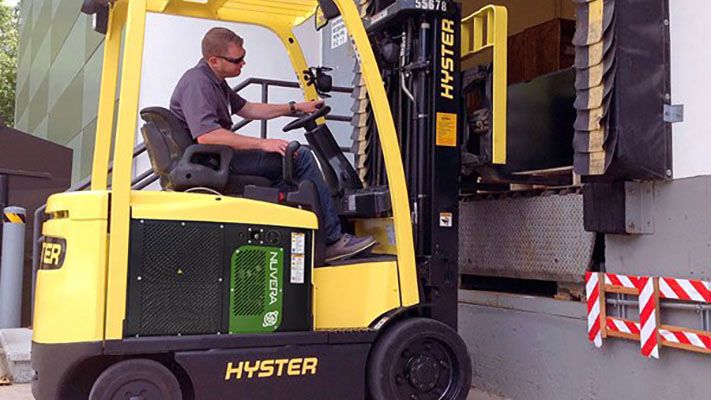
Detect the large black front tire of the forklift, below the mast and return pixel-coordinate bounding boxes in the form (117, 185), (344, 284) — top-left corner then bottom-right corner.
(368, 318), (472, 400)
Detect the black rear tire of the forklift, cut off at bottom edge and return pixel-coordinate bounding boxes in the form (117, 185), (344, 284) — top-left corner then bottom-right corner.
(89, 359), (183, 400)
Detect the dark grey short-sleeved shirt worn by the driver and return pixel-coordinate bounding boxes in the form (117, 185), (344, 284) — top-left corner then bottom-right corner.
(170, 60), (247, 139)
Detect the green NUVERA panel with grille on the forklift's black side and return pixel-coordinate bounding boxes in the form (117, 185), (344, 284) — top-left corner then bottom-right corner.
(230, 245), (284, 333)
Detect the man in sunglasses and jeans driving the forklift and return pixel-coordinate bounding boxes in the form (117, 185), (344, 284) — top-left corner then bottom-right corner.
(170, 28), (375, 262)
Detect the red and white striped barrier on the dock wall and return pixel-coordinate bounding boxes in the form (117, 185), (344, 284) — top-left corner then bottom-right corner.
(585, 272), (711, 358)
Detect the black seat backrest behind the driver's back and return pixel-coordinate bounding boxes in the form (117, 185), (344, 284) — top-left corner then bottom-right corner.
(140, 107), (195, 189)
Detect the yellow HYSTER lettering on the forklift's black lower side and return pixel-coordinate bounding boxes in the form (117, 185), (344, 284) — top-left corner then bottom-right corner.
(225, 357), (318, 381)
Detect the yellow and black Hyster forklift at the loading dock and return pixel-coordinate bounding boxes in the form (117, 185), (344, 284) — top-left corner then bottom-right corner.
(32, 0), (478, 400)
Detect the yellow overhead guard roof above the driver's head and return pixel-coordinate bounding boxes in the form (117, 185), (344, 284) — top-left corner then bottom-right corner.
(147, 0), (318, 26)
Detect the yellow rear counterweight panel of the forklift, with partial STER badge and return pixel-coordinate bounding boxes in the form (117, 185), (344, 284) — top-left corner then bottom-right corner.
(33, 192), (108, 343)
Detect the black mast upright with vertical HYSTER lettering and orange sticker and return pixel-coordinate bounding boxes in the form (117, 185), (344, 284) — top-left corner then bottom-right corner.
(425, 7), (462, 329)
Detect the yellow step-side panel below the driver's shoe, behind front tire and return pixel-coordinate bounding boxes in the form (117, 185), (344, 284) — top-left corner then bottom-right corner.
(314, 261), (401, 329)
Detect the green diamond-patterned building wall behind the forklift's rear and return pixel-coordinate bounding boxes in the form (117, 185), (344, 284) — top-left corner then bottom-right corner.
(15, 0), (103, 182)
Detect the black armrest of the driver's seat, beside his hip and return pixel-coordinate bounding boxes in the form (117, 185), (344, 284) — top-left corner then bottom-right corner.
(170, 144), (234, 191)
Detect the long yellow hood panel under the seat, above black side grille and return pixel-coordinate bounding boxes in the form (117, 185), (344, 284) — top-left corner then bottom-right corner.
(131, 191), (318, 229)
